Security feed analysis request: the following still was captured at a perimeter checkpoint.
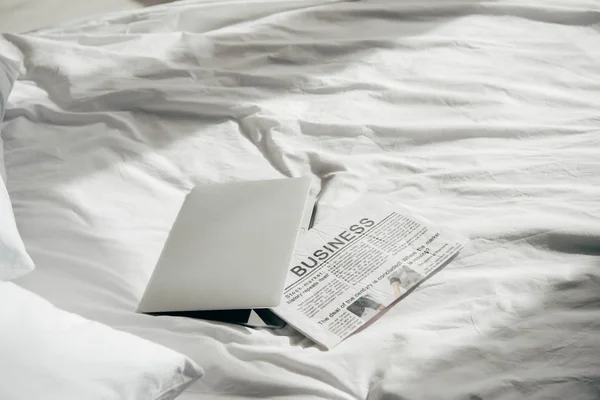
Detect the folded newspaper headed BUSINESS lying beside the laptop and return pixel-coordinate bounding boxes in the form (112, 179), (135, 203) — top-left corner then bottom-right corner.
(273, 203), (468, 349)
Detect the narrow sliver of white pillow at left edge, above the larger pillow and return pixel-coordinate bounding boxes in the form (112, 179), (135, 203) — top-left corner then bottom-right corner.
(0, 56), (34, 280)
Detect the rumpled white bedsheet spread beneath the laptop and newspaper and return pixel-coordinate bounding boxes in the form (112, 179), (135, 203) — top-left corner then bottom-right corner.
(0, 0), (600, 400)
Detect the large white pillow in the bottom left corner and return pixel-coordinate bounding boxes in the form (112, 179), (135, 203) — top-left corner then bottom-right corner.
(0, 282), (202, 400)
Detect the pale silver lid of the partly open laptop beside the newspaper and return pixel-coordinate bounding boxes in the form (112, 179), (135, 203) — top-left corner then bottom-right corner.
(138, 178), (312, 313)
